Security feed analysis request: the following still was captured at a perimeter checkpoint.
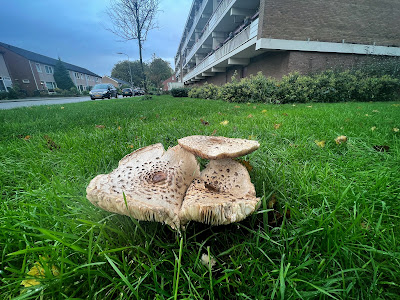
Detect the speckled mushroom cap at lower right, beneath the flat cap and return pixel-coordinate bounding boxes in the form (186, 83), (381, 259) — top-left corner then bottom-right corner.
(179, 159), (259, 225)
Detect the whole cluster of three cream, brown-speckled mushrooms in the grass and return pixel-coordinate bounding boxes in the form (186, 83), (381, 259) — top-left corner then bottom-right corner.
(86, 135), (259, 229)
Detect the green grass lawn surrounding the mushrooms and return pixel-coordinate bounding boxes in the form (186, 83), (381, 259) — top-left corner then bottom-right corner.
(0, 96), (400, 299)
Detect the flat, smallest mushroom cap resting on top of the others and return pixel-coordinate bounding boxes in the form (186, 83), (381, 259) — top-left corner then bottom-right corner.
(178, 135), (260, 159)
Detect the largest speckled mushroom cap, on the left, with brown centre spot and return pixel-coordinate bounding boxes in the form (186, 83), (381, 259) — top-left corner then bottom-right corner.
(86, 144), (200, 228)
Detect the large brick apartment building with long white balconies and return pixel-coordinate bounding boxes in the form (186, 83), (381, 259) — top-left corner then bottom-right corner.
(175, 0), (400, 84)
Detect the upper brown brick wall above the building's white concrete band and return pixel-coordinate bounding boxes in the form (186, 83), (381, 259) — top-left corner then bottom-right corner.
(258, 0), (400, 46)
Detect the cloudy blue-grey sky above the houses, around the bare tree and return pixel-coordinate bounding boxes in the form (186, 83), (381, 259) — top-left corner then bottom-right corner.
(0, 0), (192, 76)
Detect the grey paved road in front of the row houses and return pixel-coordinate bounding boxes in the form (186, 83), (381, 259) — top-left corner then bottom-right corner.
(0, 96), (112, 109)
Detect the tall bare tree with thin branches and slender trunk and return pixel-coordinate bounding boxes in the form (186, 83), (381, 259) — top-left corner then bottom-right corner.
(107, 0), (159, 92)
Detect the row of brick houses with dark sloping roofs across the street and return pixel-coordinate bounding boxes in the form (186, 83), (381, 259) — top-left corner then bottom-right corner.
(0, 42), (101, 95)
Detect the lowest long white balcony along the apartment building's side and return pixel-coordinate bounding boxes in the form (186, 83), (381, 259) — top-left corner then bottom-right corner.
(183, 18), (259, 83)
